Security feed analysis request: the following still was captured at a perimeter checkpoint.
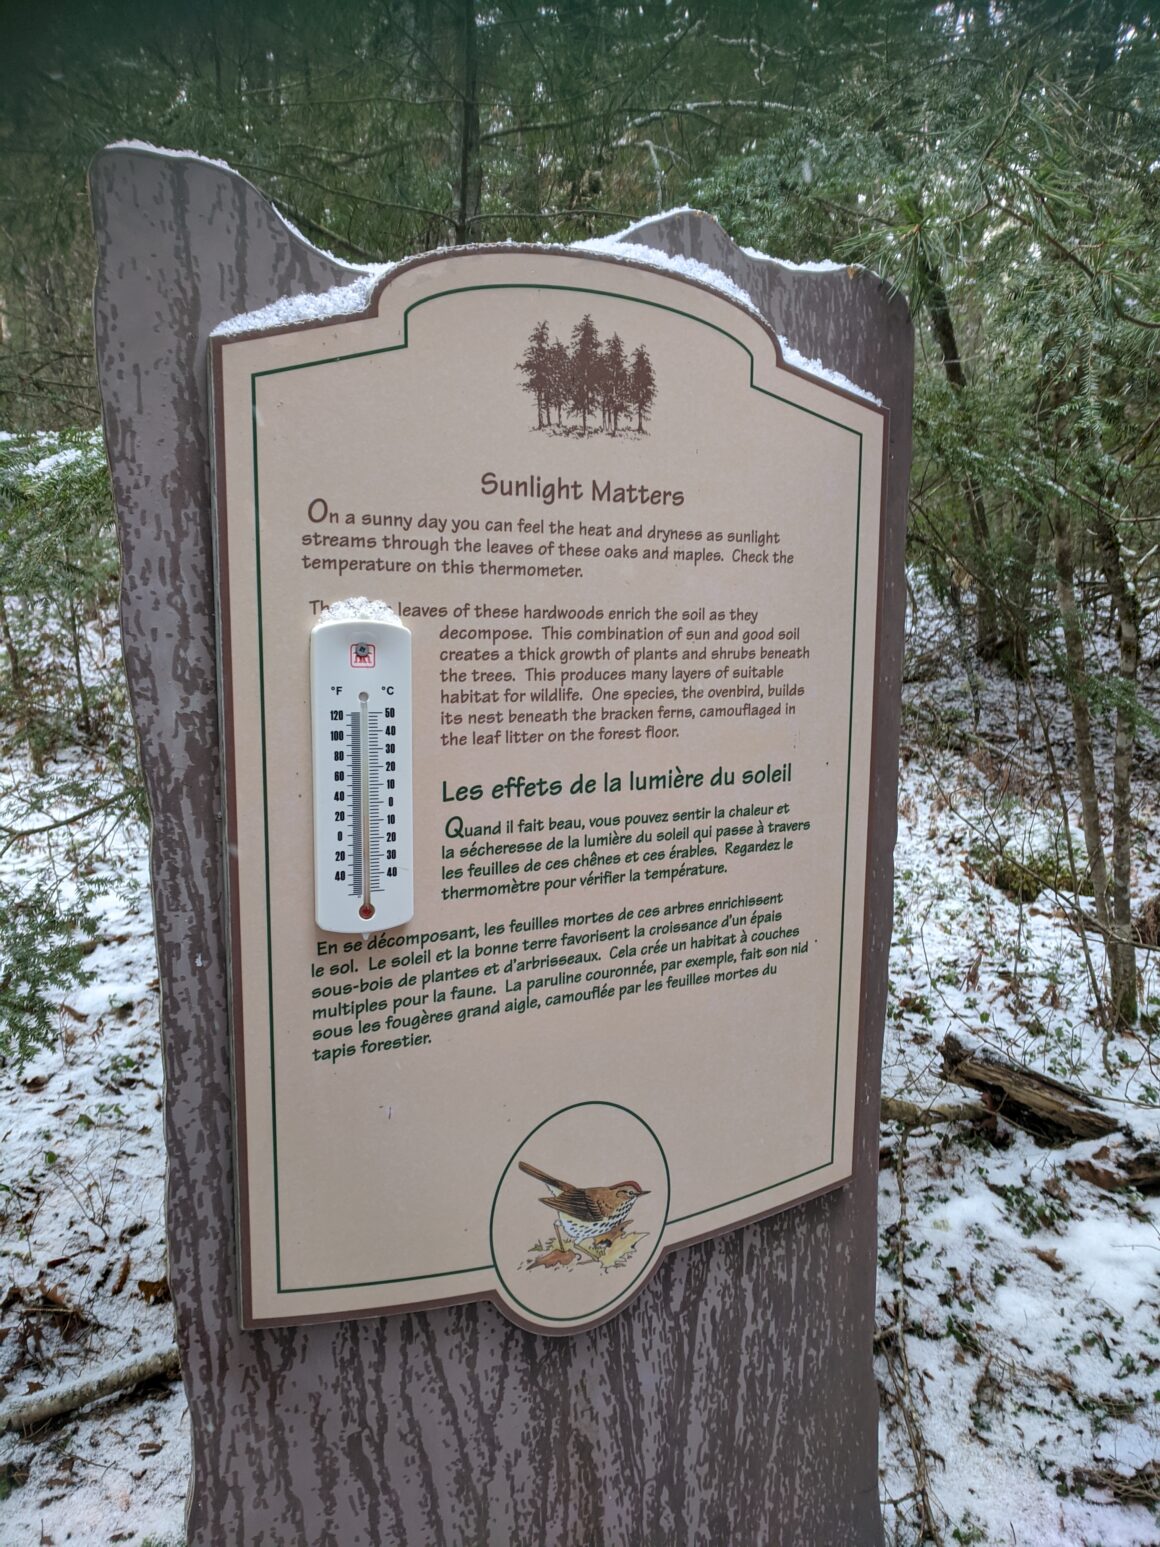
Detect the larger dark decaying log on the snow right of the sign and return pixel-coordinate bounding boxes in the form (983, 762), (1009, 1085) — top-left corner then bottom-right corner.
(939, 1033), (1121, 1145)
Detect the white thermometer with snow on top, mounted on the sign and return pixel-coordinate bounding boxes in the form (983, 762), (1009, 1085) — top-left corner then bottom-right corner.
(311, 602), (415, 934)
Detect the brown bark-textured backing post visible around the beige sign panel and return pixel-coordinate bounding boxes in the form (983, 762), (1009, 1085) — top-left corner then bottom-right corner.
(91, 149), (911, 1547)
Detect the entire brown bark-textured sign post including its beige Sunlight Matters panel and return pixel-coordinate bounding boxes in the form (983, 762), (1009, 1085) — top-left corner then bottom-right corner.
(91, 147), (911, 1547)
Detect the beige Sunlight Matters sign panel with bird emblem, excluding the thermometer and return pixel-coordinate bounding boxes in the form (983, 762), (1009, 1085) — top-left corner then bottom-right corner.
(213, 249), (886, 1332)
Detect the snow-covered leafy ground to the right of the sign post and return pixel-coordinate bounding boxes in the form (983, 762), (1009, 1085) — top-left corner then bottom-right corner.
(877, 588), (1160, 1547)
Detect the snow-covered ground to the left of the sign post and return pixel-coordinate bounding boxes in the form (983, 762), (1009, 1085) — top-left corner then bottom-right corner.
(0, 804), (189, 1547)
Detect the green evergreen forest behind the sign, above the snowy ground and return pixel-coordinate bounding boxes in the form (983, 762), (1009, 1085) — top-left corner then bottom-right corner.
(0, 0), (1160, 990)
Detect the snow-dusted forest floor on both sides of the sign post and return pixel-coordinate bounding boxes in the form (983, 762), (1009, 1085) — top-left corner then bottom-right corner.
(0, 583), (1160, 1547)
